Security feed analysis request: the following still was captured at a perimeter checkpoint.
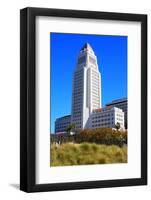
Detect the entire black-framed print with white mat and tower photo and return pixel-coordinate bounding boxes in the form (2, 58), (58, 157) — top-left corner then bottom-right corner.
(20, 8), (147, 192)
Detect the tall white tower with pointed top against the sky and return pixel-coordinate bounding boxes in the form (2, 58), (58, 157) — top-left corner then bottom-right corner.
(71, 43), (101, 129)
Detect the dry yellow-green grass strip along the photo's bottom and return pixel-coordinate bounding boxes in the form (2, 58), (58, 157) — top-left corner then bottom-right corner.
(50, 143), (127, 166)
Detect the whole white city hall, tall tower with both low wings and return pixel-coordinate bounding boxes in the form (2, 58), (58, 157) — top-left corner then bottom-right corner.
(55, 43), (124, 133)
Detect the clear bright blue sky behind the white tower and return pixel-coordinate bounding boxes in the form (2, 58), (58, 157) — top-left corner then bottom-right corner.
(50, 33), (127, 132)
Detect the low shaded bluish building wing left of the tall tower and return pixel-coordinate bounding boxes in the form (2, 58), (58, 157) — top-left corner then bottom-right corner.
(55, 115), (71, 133)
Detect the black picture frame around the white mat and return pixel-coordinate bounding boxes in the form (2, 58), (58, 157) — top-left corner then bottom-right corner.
(20, 7), (147, 192)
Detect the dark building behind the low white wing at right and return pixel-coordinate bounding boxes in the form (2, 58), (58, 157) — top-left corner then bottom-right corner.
(106, 98), (128, 129)
